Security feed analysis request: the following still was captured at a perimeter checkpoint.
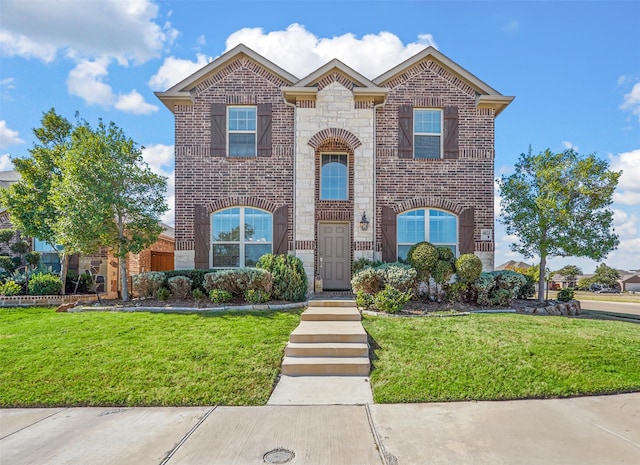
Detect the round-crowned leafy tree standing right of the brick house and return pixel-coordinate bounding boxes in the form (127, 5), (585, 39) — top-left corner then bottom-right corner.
(498, 149), (621, 301)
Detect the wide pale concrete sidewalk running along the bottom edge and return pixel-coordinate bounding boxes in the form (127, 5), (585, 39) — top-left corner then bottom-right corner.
(0, 393), (640, 465)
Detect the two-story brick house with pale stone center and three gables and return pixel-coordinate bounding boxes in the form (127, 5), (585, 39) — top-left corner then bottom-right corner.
(157, 45), (513, 290)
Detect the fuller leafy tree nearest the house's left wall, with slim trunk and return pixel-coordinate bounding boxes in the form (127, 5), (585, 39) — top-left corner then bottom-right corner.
(54, 121), (168, 301)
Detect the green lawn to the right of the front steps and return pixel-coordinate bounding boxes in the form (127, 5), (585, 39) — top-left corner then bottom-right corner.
(363, 314), (640, 403)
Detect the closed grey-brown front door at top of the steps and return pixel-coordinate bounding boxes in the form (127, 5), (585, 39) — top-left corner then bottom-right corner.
(318, 223), (351, 291)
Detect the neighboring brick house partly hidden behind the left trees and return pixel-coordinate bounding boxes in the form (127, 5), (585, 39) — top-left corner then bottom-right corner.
(0, 171), (174, 297)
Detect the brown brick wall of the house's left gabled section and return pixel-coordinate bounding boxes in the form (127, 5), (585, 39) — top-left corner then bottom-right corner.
(174, 56), (294, 260)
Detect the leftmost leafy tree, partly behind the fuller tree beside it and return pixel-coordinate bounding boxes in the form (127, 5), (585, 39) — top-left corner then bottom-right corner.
(0, 108), (74, 292)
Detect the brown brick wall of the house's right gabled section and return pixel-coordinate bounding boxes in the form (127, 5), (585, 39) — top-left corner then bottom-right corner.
(376, 60), (495, 258)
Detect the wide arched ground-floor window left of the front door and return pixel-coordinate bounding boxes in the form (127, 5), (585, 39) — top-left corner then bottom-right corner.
(211, 207), (273, 268)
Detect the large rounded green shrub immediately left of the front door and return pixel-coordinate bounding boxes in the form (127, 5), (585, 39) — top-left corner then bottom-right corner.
(256, 254), (308, 302)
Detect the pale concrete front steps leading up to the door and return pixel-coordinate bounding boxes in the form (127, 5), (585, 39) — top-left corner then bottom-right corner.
(282, 300), (370, 376)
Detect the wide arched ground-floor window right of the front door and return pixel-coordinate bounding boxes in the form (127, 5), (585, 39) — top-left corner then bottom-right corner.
(397, 208), (458, 261)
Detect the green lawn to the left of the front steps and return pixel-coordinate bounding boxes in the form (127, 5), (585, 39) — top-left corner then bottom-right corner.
(0, 308), (300, 407)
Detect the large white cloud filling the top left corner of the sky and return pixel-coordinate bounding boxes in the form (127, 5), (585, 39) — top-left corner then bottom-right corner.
(0, 0), (177, 63)
